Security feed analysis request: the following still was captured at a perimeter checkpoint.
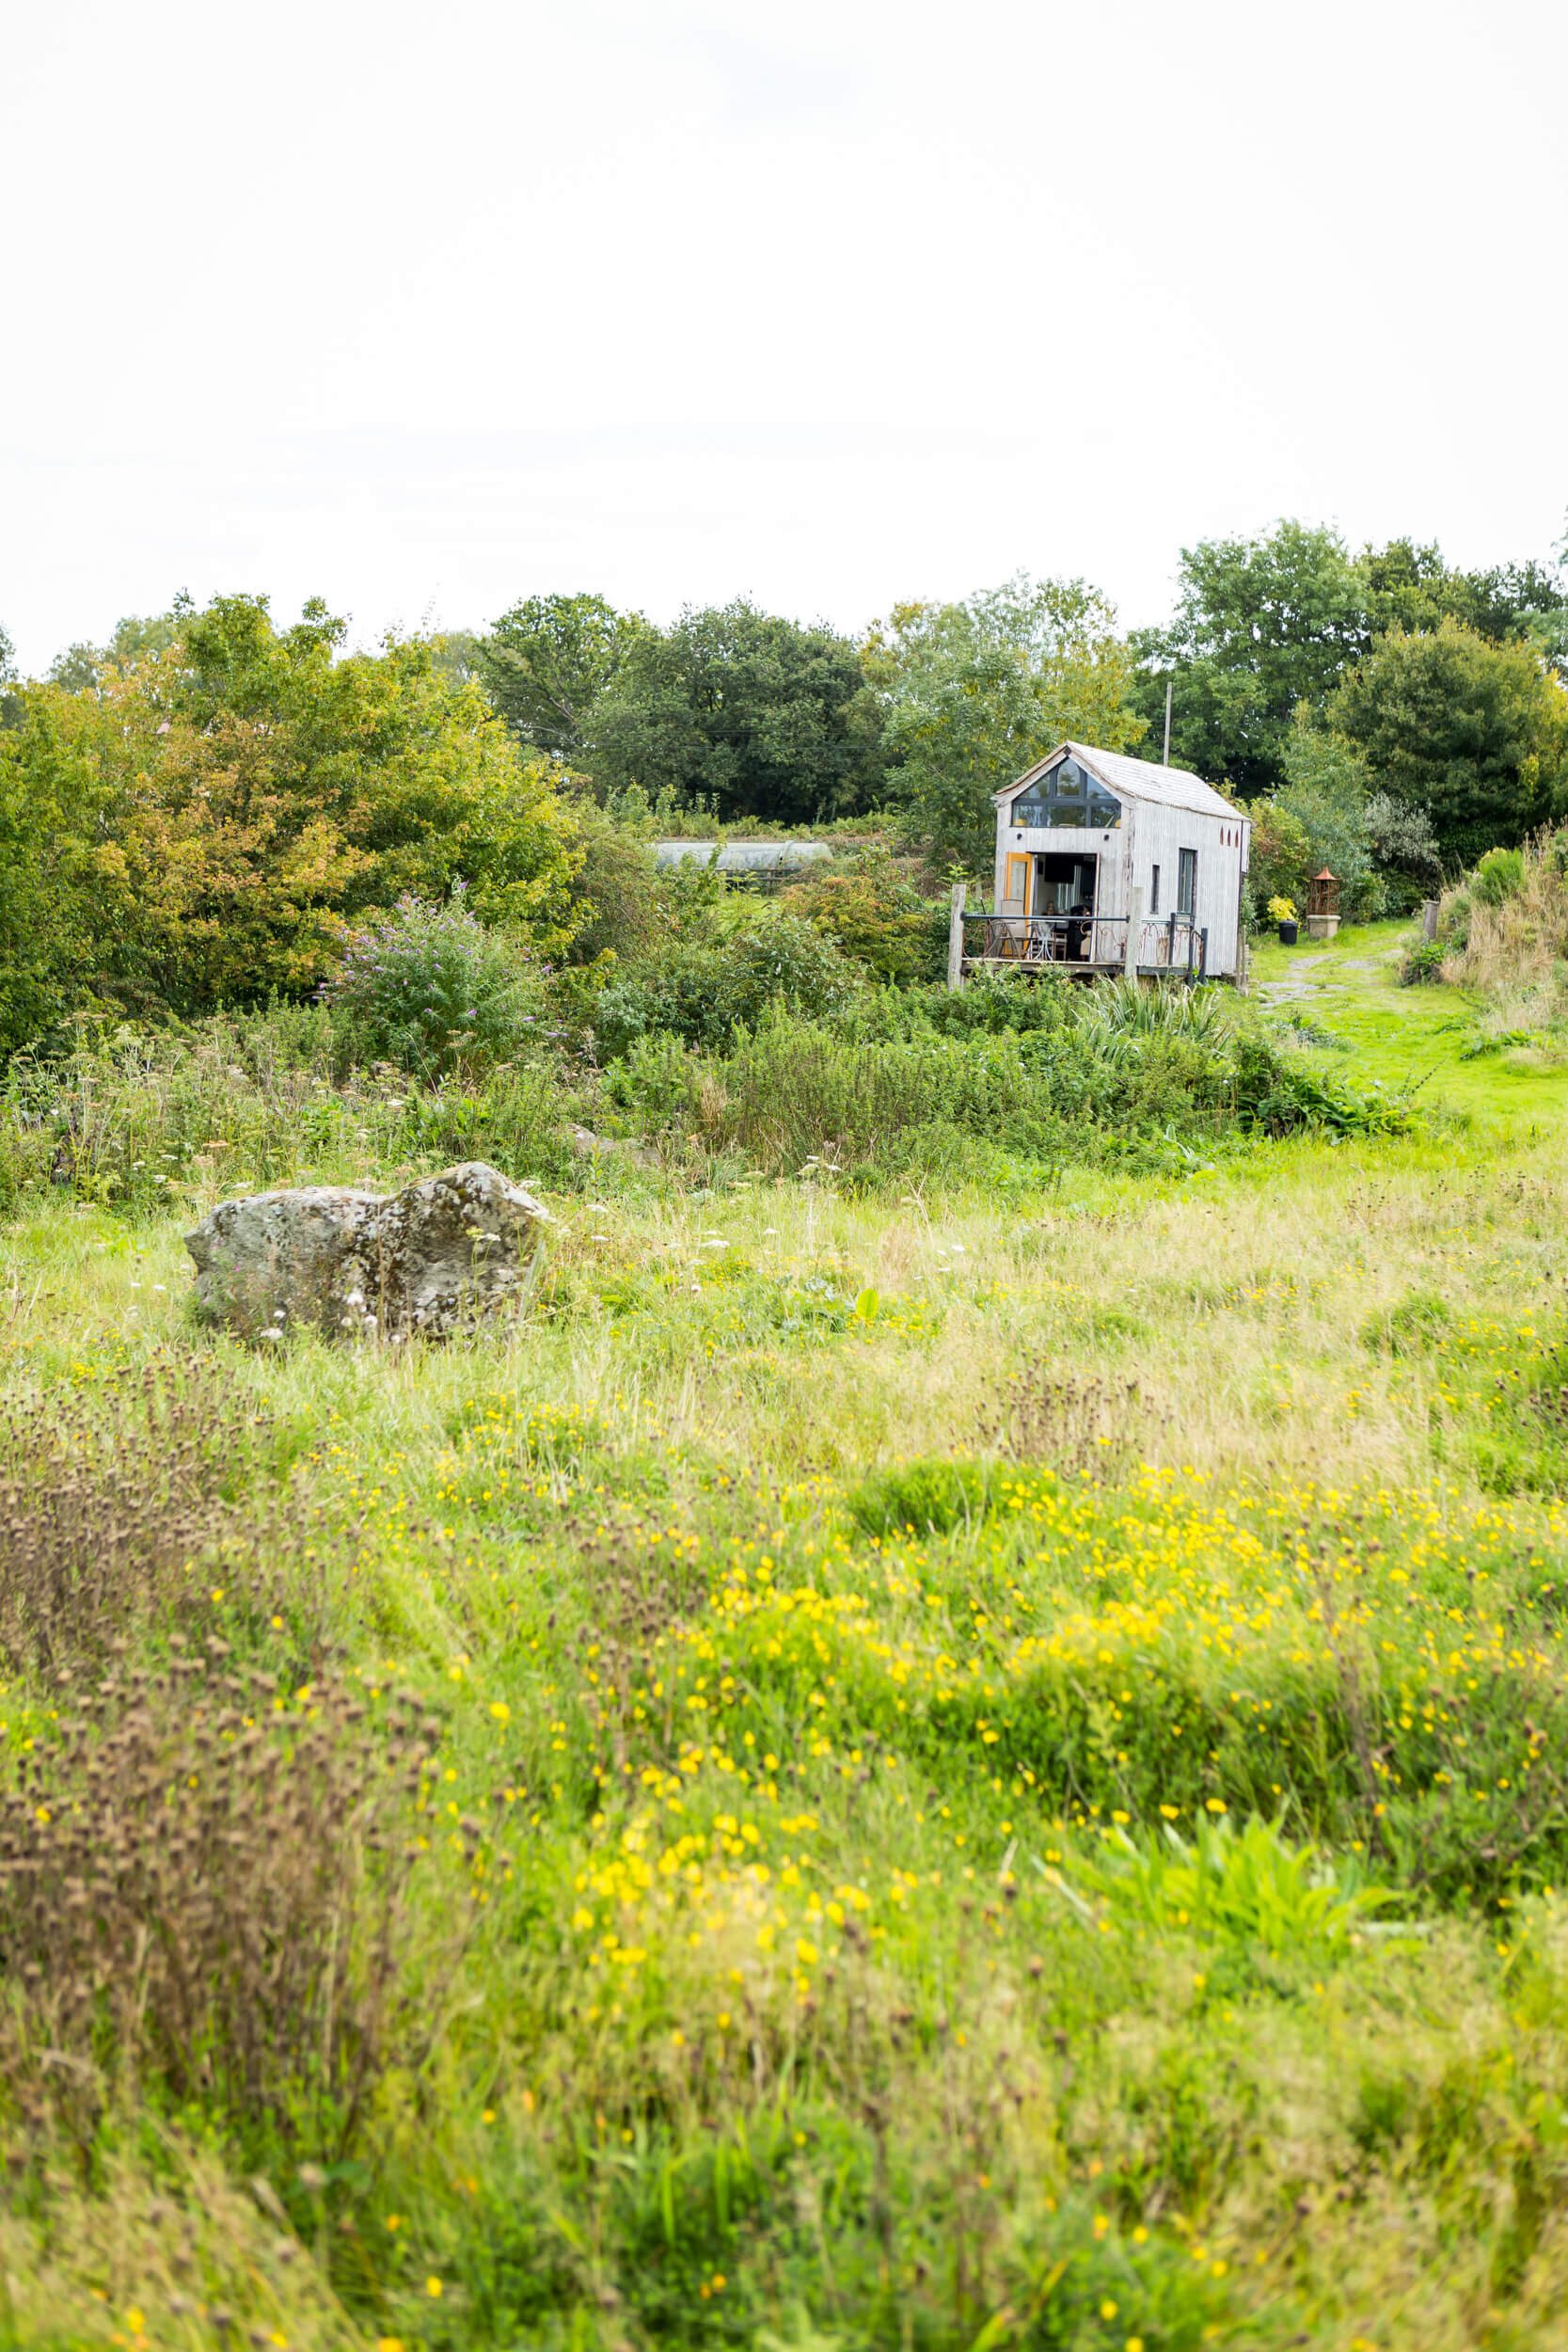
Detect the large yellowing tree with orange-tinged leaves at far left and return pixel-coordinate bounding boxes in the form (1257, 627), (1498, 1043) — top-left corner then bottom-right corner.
(0, 596), (578, 1033)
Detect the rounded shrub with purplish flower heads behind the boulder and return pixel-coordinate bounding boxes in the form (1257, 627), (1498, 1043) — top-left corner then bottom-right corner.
(320, 882), (546, 1077)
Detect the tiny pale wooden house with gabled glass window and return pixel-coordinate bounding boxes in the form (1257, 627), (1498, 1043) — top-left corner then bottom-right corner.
(991, 743), (1251, 981)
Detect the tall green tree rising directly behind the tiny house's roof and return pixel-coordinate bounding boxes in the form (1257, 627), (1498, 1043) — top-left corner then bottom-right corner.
(1131, 520), (1366, 795)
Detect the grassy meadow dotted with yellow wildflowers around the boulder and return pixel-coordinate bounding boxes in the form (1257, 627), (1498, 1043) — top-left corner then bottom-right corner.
(0, 930), (1568, 2352)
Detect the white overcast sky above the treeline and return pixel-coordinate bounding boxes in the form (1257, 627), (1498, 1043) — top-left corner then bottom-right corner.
(0, 0), (1568, 671)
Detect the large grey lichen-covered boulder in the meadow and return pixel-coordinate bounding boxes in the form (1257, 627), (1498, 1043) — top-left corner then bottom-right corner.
(185, 1160), (550, 1341)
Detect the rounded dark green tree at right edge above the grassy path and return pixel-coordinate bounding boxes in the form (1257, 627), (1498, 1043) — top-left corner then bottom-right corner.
(1328, 621), (1568, 866)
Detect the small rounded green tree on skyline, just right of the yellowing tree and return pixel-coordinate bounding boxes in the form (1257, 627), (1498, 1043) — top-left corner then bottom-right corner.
(479, 596), (646, 760)
